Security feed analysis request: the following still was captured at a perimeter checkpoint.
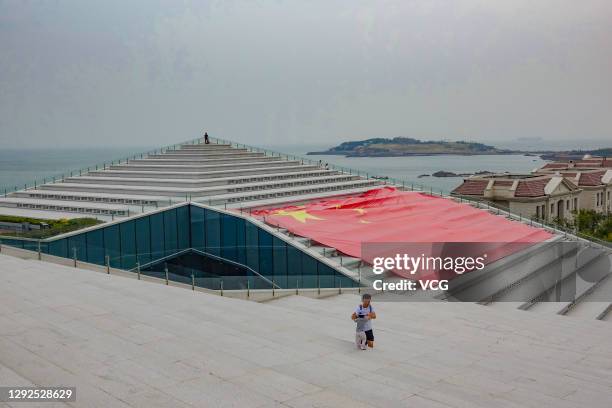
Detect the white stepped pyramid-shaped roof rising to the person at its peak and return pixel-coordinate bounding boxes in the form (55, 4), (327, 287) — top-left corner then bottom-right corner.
(0, 141), (380, 220)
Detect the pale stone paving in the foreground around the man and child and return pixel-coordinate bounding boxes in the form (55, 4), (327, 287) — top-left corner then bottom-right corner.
(0, 255), (612, 408)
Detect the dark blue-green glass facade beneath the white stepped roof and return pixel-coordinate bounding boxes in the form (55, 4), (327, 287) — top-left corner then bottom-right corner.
(1, 204), (358, 289)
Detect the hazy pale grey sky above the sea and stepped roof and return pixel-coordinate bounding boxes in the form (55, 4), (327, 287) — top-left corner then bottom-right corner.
(0, 0), (612, 147)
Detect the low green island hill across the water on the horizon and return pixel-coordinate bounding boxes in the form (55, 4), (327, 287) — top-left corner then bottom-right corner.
(308, 137), (516, 157)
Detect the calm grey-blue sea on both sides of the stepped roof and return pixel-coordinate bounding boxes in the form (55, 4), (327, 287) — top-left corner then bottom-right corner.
(0, 146), (544, 193)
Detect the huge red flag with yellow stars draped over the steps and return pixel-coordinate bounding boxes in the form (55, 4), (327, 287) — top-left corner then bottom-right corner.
(252, 187), (552, 278)
